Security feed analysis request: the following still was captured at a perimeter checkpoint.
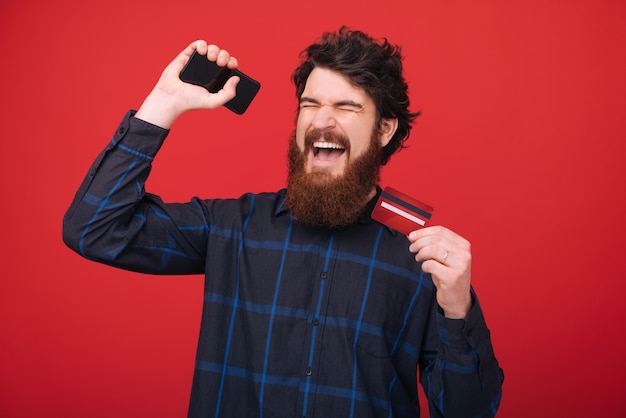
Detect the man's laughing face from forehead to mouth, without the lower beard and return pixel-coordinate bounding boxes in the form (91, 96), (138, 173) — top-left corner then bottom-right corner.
(296, 67), (385, 178)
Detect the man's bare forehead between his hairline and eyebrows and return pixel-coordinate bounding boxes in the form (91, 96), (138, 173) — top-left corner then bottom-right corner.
(302, 67), (374, 106)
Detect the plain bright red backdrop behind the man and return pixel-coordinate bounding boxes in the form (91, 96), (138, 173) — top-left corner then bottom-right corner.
(0, 0), (626, 417)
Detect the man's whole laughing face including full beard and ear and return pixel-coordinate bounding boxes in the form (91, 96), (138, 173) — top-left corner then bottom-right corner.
(287, 68), (396, 228)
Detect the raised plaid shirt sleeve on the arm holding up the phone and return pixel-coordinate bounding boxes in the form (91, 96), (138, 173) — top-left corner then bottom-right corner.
(63, 111), (208, 274)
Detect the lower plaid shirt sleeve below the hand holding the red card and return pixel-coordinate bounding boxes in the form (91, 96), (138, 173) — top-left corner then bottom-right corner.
(420, 291), (504, 418)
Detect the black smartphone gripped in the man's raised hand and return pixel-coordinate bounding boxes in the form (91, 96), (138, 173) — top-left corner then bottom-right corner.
(179, 51), (261, 115)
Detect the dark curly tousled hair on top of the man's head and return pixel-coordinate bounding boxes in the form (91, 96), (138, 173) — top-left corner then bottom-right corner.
(292, 26), (420, 165)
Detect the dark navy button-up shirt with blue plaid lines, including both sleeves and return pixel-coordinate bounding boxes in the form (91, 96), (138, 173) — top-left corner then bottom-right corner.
(63, 112), (503, 418)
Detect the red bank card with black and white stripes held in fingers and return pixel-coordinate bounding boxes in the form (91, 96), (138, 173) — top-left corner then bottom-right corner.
(372, 187), (433, 235)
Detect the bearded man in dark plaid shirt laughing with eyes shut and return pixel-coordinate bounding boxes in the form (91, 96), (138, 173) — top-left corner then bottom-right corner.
(63, 28), (503, 418)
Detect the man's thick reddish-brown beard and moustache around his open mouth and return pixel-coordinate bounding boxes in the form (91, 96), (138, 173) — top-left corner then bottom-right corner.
(287, 130), (382, 229)
